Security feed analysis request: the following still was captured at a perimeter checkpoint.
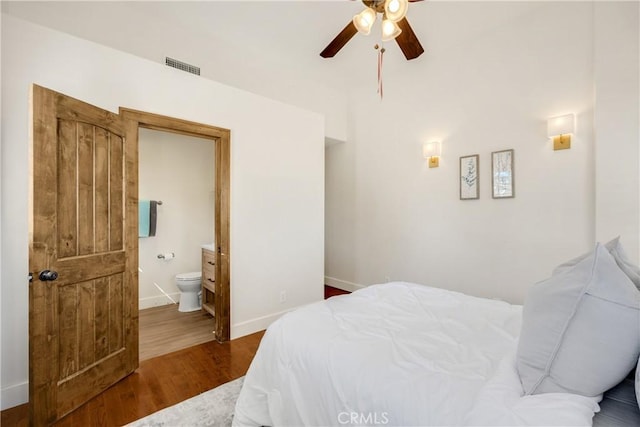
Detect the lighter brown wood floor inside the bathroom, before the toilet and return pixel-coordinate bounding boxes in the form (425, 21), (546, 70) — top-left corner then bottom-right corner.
(139, 304), (215, 361)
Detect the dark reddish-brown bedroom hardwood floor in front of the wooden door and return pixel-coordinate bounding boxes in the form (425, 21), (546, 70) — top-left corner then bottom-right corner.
(0, 331), (264, 427)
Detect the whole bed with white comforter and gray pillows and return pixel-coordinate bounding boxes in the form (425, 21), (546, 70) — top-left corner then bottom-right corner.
(233, 241), (640, 426)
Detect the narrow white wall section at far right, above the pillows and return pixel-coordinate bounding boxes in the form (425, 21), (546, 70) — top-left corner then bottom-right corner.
(594, 2), (640, 262)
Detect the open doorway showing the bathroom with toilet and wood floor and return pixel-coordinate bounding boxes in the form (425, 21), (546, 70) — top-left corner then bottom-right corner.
(138, 128), (215, 361)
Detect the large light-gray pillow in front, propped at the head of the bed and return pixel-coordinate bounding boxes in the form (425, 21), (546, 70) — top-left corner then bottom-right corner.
(516, 244), (640, 397)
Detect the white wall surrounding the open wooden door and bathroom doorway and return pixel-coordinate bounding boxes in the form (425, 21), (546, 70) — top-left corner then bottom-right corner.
(0, 15), (324, 409)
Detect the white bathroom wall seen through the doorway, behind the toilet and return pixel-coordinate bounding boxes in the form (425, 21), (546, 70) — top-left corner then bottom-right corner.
(138, 129), (215, 309)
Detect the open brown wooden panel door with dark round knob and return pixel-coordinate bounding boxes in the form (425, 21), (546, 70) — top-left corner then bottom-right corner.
(29, 85), (138, 425)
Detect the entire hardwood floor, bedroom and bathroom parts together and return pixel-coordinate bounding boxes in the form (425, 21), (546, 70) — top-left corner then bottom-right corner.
(0, 286), (349, 427)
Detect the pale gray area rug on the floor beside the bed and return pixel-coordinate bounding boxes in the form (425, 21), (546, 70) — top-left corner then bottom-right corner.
(127, 377), (244, 427)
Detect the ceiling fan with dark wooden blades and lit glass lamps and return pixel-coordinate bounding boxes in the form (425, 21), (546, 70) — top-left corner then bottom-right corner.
(320, 0), (424, 60)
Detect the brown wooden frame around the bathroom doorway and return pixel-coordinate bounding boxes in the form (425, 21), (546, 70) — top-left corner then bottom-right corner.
(119, 107), (231, 342)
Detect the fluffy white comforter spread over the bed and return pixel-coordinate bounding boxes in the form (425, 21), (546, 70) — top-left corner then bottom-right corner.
(234, 282), (597, 426)
